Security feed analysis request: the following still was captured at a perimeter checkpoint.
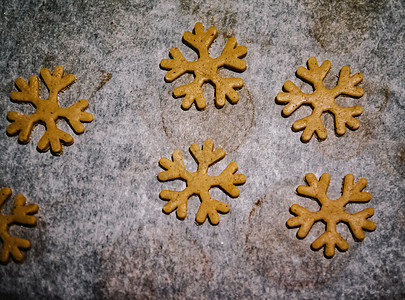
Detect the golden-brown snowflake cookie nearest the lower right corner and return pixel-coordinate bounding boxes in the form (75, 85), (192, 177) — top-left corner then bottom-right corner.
(287, 173), (377, 258)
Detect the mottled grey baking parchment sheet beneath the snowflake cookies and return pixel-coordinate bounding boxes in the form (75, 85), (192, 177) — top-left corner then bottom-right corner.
(0, 0), (405, 299)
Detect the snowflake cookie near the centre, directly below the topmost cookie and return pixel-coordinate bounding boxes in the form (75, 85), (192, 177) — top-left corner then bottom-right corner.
(158, 139), (246, 225)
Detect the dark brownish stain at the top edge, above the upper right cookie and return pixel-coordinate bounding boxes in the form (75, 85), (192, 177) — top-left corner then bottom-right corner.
(307, 0), (385, 52)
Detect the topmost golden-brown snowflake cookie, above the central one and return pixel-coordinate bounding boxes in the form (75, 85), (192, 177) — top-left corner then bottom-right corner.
(160, 22), (247, 110)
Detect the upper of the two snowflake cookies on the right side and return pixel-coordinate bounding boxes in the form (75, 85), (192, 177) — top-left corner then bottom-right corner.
(276, 57), (364, 143)
